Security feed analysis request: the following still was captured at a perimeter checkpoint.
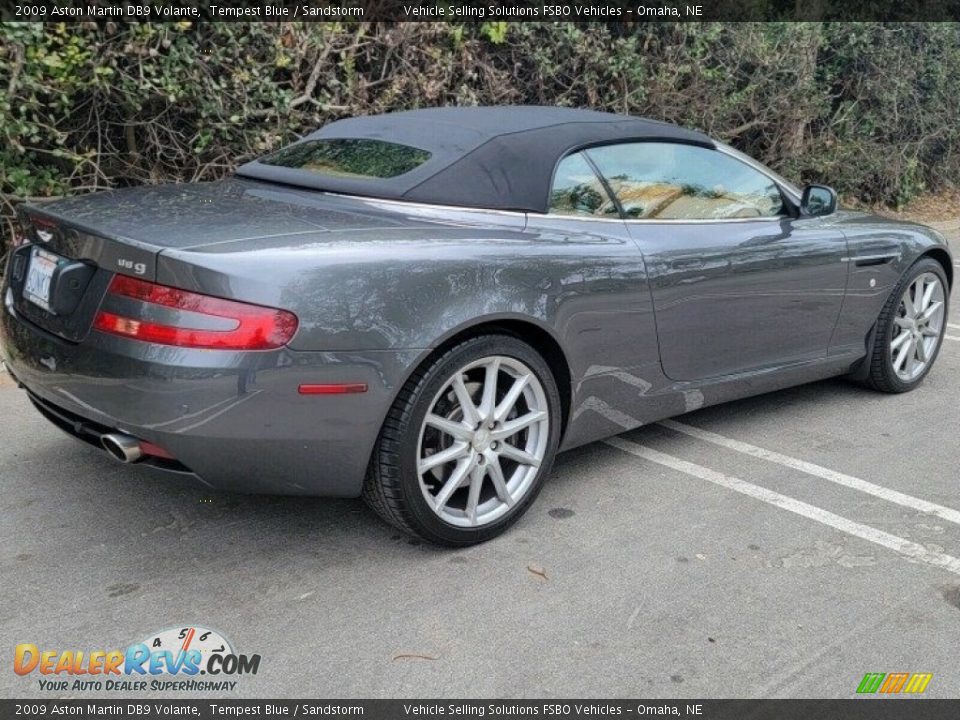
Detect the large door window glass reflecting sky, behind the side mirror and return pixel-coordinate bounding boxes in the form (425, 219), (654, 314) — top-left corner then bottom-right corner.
(588, 142), (786, 220)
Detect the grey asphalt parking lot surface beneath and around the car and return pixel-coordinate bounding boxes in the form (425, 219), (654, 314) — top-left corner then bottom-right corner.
(0, 224), (960, 698)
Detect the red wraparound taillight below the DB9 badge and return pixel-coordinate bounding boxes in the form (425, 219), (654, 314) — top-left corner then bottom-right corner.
(93, 275), (297, 350)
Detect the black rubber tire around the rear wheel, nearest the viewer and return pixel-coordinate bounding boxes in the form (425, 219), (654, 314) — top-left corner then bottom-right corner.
(363, 335), (561, 547)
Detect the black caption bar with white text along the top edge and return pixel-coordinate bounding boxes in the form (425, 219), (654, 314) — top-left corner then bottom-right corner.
(0, 0), (960, 23)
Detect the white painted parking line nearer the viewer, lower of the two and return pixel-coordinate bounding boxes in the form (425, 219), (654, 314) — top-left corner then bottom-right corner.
(604, 437), (960, 575)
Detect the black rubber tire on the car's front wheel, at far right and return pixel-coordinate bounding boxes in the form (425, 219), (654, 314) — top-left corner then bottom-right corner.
(865, 258), (950, 393)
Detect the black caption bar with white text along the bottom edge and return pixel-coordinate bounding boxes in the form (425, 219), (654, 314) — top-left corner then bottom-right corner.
(0, 696), (960, 720)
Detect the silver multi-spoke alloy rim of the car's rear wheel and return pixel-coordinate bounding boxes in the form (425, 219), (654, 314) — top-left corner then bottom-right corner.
(417, 355), (550, 527)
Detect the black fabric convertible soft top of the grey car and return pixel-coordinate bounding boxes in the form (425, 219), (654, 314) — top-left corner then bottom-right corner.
(237, 106), (714, 212)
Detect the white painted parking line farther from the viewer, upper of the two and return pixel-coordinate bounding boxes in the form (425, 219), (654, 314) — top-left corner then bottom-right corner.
(660, 420), (960, 525)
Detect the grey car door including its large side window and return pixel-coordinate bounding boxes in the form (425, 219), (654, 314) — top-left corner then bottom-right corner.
(587, 142), (847, 381)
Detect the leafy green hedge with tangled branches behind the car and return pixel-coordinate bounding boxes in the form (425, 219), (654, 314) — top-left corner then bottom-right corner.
(0, 23), (960, 250)
